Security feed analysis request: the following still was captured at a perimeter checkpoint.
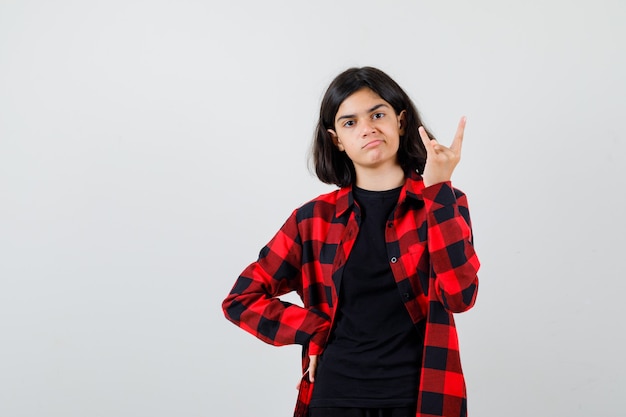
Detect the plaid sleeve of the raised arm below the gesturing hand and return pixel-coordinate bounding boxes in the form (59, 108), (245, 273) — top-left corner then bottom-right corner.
(423, 181), (480, 313)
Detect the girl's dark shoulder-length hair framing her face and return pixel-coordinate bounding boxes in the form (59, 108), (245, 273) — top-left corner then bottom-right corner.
(311, 67), (434, 187)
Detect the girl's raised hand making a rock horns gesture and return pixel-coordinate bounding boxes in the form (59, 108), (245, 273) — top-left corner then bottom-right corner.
(419, 116), (466, 187)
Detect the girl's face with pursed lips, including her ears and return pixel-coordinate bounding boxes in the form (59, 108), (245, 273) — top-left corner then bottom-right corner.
(328, 88), (406, 177)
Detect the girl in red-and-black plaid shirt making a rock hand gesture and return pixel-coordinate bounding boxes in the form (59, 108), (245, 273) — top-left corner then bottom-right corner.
(223, 67), (479, 417)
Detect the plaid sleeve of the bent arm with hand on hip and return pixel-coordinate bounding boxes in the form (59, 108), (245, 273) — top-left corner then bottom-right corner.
(222, 211), (330, 354)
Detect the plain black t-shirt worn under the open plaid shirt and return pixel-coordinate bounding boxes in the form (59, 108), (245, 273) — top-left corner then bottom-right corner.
(311, 187), (423, 407)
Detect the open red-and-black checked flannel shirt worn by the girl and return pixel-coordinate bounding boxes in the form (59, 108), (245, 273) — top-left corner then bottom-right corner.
(222, 173), (480, 417)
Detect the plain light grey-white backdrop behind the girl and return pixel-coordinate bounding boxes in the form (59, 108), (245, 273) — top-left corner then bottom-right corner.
(0, 0), (626, 417)
